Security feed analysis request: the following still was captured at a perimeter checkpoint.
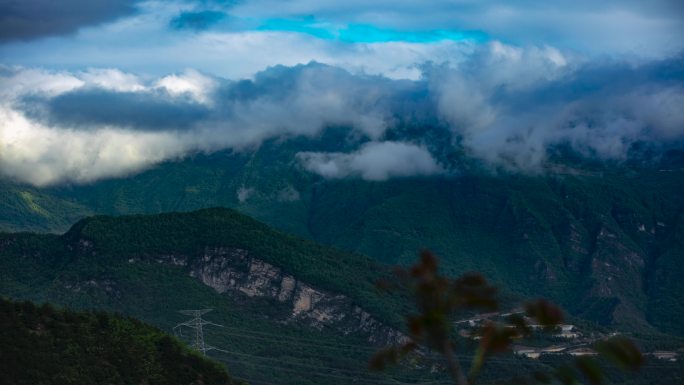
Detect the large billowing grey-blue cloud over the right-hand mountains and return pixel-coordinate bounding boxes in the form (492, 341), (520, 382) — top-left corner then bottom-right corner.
(426, 46), (684, 171)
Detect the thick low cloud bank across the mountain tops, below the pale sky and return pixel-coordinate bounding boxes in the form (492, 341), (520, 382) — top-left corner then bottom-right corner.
(0, 42), (684, 185)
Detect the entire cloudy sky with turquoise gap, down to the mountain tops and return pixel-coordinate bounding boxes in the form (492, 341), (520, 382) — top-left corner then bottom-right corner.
(0, 0), (684, 185)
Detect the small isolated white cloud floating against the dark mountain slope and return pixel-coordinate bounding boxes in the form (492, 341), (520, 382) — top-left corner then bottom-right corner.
(297, 141), (444, 181)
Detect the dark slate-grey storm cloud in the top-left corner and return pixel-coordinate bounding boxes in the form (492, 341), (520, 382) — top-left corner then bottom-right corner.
(0, 0), (135, 42)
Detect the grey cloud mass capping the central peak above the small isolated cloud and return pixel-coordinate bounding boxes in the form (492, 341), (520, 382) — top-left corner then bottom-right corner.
(218, 63), (412, 138)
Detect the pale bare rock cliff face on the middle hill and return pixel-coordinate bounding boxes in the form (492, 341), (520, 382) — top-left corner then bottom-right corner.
(150, 248), (407, 346)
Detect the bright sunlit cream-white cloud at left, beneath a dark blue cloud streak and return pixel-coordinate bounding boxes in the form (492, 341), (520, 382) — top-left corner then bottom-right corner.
(0, 106), (187, 186)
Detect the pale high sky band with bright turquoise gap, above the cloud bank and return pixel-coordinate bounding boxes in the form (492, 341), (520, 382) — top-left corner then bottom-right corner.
(0, 0), (684, 80)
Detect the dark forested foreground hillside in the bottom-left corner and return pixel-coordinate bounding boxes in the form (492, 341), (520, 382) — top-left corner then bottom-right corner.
(0, 299), (236, 385)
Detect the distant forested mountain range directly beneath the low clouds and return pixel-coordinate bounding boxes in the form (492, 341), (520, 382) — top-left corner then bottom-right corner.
(0, 140), (684, 335)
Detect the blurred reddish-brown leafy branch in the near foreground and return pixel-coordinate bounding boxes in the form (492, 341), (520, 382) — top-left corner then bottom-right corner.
(370, 251), (643, 385)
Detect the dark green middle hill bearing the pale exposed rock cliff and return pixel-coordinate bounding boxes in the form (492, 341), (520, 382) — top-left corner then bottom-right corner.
(0, 209), (424, 384)
